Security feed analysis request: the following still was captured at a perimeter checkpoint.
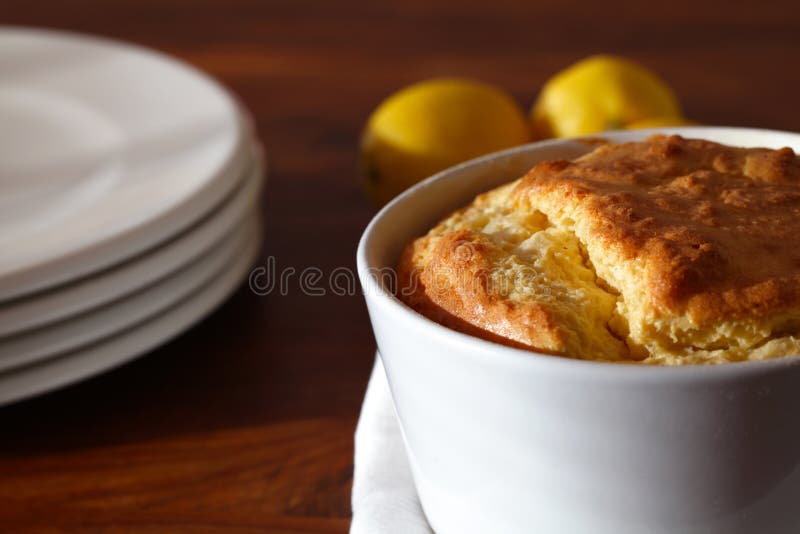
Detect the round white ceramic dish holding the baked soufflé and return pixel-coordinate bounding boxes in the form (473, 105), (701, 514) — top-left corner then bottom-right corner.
(358, 128), (800, 534)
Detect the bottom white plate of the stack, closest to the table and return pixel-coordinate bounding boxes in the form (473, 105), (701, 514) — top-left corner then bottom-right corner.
(0, 220), (261, 405)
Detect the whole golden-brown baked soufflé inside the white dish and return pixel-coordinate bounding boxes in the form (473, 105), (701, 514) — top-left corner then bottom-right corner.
(399, 137), (800, 364)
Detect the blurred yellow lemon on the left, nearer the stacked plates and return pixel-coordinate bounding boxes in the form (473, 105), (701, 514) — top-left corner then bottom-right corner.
(360, 78), (530, 206)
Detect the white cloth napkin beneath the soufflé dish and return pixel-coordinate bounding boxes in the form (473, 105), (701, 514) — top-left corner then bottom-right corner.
(350, 355), (433, 534)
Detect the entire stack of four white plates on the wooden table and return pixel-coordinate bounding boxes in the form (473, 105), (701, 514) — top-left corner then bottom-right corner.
(0, 28), (264, 404)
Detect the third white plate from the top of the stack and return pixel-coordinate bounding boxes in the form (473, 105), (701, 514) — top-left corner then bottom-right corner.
(0, 212), (258, 372)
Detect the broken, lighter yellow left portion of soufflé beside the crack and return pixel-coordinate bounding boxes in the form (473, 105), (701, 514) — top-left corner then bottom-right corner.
(398, 182), (629, 360)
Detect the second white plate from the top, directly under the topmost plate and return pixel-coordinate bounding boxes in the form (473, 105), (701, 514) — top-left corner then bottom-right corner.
(0, 146), (264, 340)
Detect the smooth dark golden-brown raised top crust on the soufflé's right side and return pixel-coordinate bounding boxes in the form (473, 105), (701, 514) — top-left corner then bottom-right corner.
(518, 136), (800, 324)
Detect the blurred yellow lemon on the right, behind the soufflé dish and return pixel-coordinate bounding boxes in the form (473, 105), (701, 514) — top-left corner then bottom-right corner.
(531, 55), (681, 137)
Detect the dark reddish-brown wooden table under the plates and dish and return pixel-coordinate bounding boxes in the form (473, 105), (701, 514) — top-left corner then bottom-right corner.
(0, 0), (800, 533)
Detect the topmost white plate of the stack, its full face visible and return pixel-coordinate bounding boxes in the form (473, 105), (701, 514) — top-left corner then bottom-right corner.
(0, 27), (249, 300)
